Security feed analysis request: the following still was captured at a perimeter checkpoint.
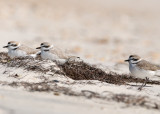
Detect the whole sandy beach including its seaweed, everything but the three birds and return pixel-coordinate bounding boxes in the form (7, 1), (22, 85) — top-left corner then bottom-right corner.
(0, 0), (160, 114)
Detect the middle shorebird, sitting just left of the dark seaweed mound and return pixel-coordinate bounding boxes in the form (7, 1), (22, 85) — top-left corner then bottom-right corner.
(36, 42), (79, 64)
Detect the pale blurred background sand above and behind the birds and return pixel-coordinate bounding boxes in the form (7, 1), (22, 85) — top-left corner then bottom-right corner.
(0, 0), (160, 63)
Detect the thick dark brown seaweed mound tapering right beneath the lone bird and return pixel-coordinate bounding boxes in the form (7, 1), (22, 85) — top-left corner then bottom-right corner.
(59, 58), (160, 85)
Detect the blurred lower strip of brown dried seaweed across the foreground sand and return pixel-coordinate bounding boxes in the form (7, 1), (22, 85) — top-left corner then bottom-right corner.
(0, 81), (160, 110)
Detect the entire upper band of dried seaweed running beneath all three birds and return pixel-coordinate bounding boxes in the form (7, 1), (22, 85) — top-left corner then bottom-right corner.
(0, 52), (160, 85)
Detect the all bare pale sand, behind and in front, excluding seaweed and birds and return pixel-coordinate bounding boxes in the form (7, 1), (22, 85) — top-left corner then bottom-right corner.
(0, 0), (160, 114)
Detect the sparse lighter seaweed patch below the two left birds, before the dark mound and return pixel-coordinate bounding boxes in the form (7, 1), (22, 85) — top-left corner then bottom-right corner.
(0, 52), (63, 74)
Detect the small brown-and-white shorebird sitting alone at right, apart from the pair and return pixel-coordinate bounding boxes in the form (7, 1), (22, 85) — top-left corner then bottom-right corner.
(125, 55), (160, 89)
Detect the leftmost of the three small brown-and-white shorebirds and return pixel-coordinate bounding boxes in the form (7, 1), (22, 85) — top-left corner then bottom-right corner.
(3, 41), (38, 58)
